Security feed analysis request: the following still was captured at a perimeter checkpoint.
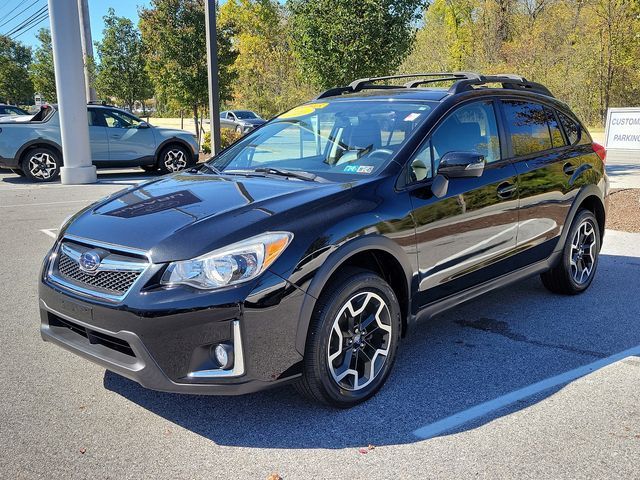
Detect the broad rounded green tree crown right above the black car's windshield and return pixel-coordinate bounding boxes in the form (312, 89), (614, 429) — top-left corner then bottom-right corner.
(287, 0), (424, 88)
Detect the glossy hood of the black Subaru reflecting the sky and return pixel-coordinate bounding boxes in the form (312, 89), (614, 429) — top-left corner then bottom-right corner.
(64, 172), (350, 263)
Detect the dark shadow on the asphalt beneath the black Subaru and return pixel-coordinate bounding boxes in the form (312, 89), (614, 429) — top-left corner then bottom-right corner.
(104, 251), (640, 449)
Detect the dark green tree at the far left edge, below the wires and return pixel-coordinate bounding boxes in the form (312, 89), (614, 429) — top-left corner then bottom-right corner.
(0, 35), (33, 104)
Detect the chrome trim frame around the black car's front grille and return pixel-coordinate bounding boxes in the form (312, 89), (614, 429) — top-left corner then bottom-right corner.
(46, 235), (153, 303)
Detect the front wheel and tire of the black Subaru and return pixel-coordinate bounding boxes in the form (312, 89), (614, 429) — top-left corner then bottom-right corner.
(295, 268), (402, 408)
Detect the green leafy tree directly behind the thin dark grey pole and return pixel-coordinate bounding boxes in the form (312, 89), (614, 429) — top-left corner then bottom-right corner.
(140, 0), (236, 141)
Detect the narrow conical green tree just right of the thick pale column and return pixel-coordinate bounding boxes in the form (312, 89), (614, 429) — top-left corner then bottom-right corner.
(96, 8), (153, 109)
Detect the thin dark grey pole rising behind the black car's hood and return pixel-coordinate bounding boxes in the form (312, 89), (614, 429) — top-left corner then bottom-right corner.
(208, 0), (225, 155)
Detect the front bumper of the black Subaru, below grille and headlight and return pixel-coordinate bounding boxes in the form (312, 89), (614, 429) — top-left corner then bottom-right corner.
(39, 262), (305, 395)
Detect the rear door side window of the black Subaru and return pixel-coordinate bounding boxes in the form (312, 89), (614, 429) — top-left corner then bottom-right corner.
(502, 100), (553, 157)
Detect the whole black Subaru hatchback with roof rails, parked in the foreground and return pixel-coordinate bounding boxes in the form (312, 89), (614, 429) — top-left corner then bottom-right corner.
(40, 73), (609, 407)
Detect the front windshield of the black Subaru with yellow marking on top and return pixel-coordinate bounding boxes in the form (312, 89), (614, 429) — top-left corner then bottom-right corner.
(210, 100), (436, 178)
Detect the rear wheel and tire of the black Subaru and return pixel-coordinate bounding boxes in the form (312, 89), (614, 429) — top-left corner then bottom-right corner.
(540, 210), (601, 295)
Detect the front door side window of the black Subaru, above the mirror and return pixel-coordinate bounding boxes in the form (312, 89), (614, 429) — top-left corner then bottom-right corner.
(431, 102), (500, 172)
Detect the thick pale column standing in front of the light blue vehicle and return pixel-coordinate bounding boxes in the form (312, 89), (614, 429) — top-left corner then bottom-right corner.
(49, 0), (97, 184)
